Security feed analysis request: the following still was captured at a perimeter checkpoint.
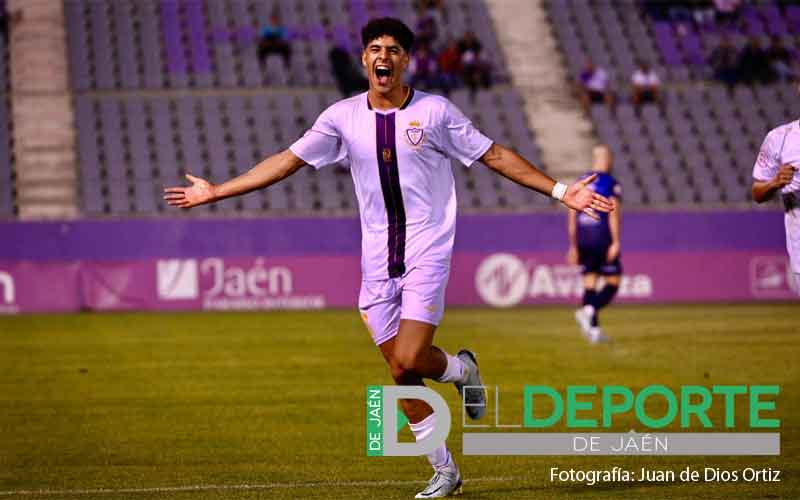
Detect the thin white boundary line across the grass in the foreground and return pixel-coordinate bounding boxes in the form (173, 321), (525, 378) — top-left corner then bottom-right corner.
(0, 477), (524, 497)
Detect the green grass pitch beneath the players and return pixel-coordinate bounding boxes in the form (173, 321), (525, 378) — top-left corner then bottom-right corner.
(0, 304), (800, 499)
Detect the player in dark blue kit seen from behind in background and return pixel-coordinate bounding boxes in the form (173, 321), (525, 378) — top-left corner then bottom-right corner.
(567, 145), (622, 344)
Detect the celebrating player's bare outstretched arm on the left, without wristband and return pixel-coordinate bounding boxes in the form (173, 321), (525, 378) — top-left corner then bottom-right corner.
(164, 149), (305, 208)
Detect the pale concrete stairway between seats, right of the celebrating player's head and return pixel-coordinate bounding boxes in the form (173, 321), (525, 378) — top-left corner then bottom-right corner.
(486, 0), (594, 179)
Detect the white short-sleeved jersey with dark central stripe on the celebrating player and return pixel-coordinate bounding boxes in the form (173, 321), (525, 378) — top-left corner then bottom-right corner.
(290, 89), (492, 281)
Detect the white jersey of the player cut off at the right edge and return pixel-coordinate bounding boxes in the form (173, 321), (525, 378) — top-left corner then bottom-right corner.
(753, 121), (800, 278)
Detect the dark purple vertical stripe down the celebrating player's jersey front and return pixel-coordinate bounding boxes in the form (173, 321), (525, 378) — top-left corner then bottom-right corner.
(375, 113), (406, 278)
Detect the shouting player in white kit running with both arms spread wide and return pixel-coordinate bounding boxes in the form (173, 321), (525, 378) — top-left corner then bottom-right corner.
(165, 18), (614, 498)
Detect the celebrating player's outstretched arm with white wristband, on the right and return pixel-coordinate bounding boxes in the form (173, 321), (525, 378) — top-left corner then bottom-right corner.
(480, 143), (614, 218)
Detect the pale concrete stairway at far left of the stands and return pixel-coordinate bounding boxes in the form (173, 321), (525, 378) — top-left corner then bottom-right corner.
(8, 0), (79, 218)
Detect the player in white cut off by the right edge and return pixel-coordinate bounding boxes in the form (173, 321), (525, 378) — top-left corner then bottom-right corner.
(753, 120), (800, 293)
